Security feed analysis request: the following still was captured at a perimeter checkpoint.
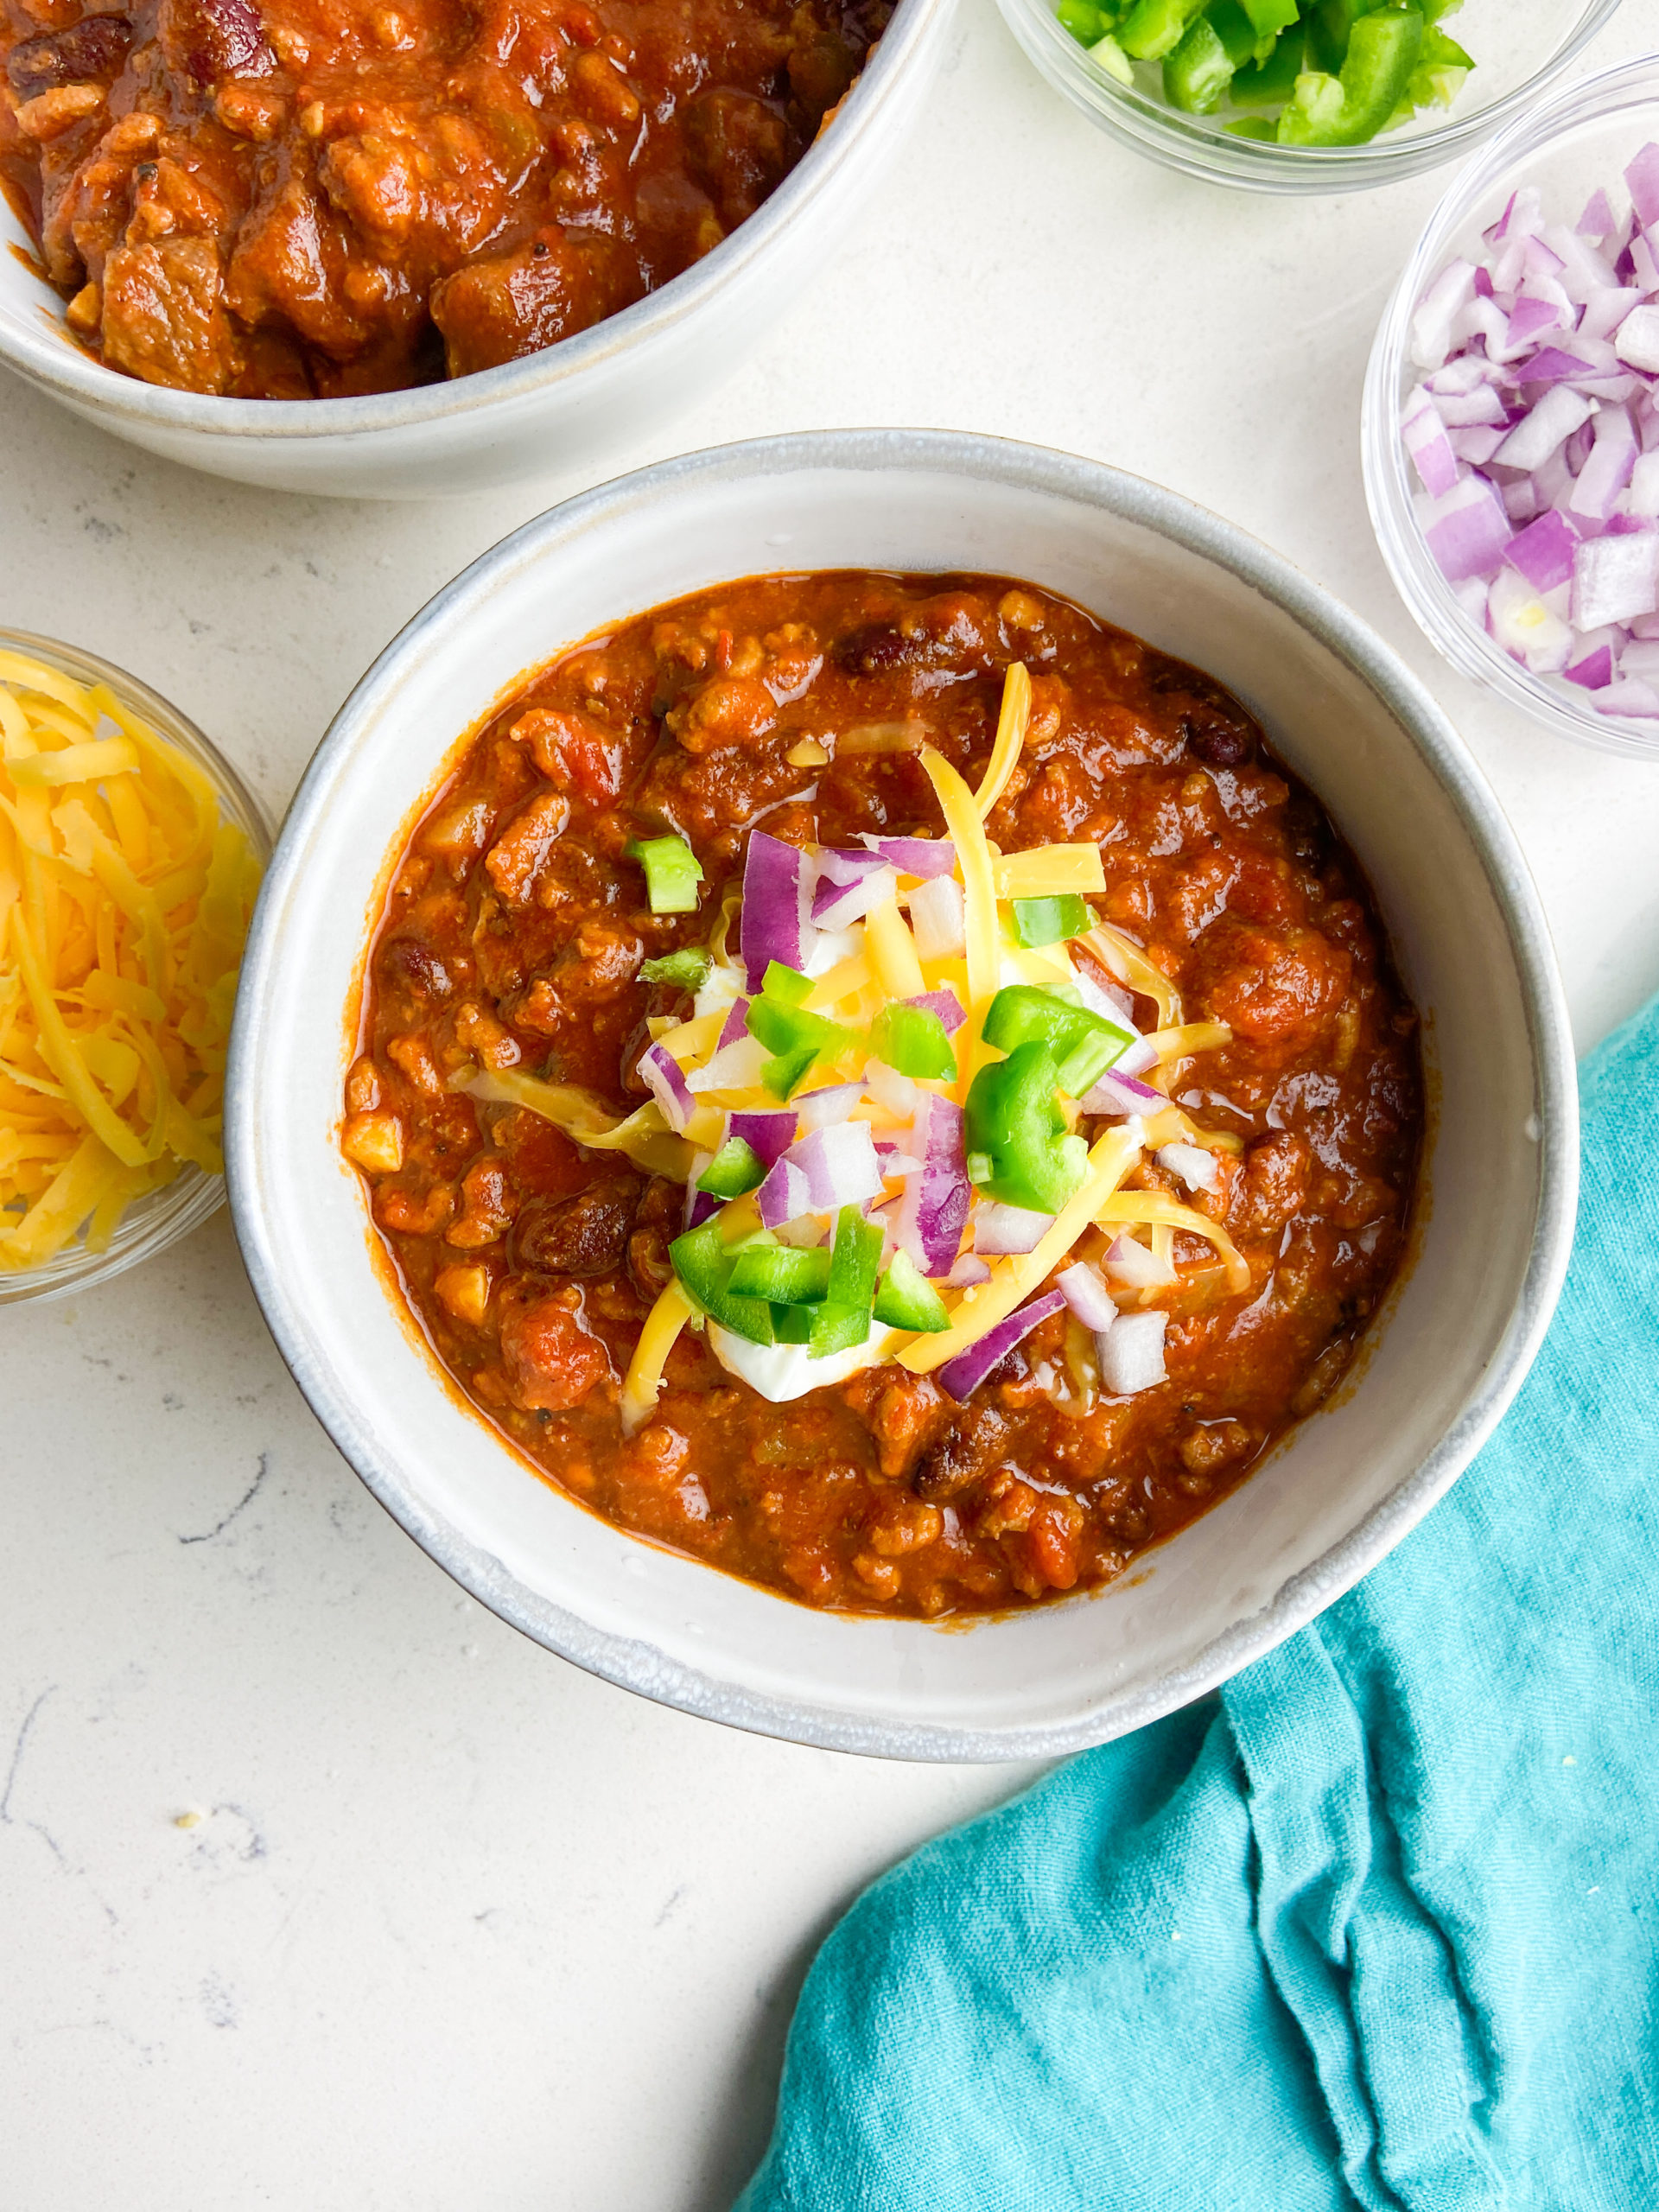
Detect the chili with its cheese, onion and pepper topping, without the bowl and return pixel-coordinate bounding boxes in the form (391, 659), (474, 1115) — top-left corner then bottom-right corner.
(343, 575), (1422, 1617)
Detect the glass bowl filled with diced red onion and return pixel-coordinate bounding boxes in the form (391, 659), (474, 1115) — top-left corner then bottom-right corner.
(1360, 55), (1659, 759)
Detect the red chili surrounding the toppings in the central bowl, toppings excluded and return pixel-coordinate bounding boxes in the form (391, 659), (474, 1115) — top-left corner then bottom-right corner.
(345, 573), (1422, 1617)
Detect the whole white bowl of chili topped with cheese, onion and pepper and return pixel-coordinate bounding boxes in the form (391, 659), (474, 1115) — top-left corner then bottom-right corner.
(228, 434), (1573, 1757)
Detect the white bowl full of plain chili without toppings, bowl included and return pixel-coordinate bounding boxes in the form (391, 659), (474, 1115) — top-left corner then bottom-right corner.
(0, 0), (947, 495)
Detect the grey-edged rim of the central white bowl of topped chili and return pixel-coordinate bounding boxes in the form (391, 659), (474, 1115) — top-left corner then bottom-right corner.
(226, 429), (1577, 1761)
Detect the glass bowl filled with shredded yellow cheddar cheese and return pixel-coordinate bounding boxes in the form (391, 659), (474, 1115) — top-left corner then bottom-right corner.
(0, 628), (270, 1305)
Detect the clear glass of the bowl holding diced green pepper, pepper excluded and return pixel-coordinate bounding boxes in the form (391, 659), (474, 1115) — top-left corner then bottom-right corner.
(998, 0), (1619, 193)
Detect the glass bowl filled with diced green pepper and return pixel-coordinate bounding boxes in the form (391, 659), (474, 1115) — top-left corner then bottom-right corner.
(1000, 0), (1619, 193)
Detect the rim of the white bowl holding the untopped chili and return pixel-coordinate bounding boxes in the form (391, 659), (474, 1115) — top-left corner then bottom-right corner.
(0, 0), (951, 440)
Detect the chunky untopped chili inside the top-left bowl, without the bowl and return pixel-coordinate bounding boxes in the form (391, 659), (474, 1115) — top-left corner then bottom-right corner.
(0, 0), (892, 400)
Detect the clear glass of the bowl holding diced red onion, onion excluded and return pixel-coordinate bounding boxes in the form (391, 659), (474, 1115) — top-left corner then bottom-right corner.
(1360, 53), (1659, 761)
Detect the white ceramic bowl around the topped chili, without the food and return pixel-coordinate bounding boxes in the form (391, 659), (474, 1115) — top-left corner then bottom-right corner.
(226, 431), (1577, 1758)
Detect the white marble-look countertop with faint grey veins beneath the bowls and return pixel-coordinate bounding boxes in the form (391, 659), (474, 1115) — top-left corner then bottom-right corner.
(0, 0), (1659, 2212)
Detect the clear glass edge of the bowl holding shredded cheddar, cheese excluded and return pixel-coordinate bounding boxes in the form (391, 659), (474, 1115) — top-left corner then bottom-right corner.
(0, 631), (270, 1305)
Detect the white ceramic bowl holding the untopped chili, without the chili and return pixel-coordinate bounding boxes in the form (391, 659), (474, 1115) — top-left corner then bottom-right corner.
(0, 0), (951, 500)
